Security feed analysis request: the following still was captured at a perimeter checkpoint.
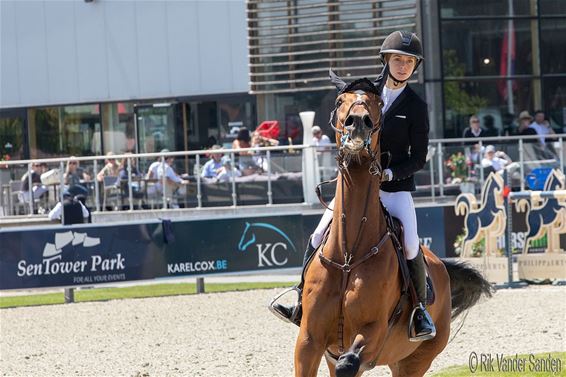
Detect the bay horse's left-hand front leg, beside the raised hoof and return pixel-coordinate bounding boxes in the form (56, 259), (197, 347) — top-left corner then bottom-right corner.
(295, 326), (325, 377)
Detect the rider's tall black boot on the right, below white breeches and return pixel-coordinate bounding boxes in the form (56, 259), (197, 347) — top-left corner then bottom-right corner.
(407, 250), (436, 342)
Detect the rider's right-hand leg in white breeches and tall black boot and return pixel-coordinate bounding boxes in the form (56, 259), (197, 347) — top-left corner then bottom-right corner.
(380, 191), (436, 341)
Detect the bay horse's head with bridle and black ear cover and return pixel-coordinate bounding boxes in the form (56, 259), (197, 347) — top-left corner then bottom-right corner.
(330, 70), (383, 172)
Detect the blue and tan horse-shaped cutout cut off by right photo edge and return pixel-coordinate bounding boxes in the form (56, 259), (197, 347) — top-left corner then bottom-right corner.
(517, 169), (566, 254)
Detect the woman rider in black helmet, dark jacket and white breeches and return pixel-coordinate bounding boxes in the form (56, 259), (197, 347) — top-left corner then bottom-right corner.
(270, 31), (436, 341)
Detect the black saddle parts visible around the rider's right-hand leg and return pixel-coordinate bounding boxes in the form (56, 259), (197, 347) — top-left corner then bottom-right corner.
(380, 201), (435, 307)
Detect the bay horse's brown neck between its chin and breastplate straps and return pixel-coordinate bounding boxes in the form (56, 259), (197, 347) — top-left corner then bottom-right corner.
(331, 166), (386, 254)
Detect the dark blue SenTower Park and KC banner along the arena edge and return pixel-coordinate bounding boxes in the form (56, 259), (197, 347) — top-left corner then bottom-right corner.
(0, 206), (564, 289)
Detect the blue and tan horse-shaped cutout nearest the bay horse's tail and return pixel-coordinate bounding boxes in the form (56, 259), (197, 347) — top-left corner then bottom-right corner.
(455, 173), (507, 258)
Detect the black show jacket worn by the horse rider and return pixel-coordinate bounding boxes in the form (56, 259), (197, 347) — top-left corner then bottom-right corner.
(380, 85), (429, 192)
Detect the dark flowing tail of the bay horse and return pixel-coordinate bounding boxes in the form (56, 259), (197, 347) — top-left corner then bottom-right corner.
(442, 260), (493, 319)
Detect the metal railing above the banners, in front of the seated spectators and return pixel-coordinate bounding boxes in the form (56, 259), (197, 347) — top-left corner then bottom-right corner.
(0, 134), (566, 217)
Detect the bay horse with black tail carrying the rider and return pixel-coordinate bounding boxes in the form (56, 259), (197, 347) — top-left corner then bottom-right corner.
(295, 71), (491, 377)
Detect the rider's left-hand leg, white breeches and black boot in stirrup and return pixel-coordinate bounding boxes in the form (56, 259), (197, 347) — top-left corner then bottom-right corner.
(269, 199), (334, 326)
